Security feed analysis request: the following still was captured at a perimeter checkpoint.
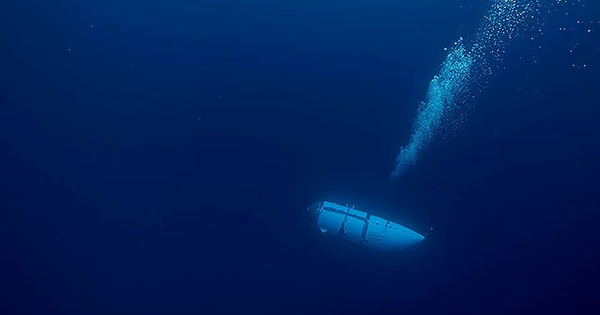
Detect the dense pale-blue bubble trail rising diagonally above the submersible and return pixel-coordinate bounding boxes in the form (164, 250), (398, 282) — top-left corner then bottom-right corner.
(391, 0), (538, 179)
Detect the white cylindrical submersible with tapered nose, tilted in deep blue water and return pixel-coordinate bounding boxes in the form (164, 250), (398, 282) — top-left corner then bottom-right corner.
(307, 201), (425, 250)
